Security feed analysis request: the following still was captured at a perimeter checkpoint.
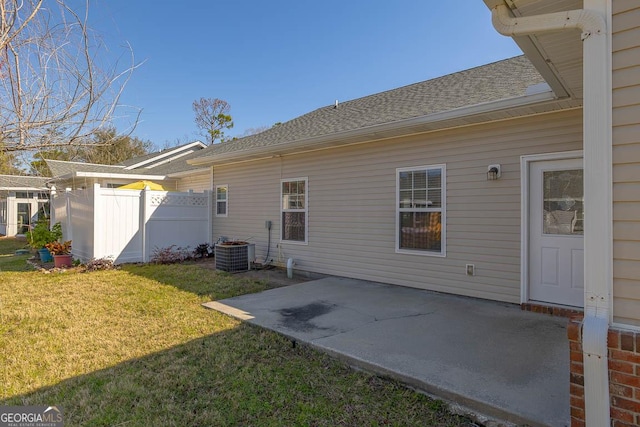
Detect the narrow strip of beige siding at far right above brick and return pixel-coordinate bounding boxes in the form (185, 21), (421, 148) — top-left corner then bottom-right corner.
(612, 0), (640, 326)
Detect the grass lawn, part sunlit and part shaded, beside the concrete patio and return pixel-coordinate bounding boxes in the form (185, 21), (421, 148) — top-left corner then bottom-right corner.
(0, 239), (473, 426)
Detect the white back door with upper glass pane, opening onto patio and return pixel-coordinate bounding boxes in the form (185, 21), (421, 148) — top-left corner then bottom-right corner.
(529, 158), (584, 307)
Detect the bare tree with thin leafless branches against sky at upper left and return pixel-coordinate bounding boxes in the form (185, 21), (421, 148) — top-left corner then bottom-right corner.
(0, 0), (140, 151)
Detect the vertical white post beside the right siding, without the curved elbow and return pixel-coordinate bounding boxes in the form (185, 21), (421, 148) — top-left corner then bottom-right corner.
(582, 0), (613, 427)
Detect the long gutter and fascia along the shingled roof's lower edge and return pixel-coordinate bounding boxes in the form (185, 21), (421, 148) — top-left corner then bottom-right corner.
(187, 91), (557, 166)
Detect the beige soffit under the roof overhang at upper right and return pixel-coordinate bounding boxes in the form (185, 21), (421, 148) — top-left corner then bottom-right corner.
(484, 0), (582, 99)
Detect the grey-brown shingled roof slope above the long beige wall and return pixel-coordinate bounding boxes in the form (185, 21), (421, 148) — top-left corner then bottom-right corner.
(199, 56), (544, 157)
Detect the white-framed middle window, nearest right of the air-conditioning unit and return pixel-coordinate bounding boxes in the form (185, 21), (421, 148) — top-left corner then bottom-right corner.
(280, 178), (308, 243)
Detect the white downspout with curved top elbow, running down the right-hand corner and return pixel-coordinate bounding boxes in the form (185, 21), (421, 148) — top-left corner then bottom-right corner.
(487, 0), (613, 427)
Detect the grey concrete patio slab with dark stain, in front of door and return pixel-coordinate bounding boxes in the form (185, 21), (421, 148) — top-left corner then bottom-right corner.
(205, 277), (570, 426)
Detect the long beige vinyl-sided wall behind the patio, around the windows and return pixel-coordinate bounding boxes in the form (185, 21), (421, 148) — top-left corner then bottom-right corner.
(213, 110), (582, 303)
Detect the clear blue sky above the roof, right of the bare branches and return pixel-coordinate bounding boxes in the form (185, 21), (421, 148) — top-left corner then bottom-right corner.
(91, 0), (521, 148)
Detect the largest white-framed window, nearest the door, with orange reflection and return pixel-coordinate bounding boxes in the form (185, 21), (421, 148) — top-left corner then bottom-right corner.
(396, 165), (446, 256)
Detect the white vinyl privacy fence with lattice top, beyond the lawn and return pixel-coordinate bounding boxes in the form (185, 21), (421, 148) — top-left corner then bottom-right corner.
(51, 184), (212, 264)
